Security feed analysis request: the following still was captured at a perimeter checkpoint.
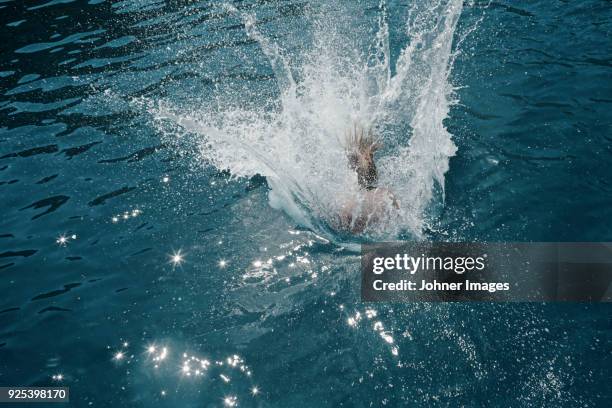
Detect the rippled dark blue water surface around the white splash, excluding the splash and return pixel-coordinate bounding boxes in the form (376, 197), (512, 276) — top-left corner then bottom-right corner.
(0, 0), (612, 408)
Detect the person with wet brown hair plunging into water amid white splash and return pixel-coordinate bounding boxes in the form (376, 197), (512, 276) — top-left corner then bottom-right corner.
(339, 125), (399, 234)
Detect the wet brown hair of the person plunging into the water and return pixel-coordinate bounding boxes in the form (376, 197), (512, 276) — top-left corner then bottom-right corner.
(346, 125), (380, 190)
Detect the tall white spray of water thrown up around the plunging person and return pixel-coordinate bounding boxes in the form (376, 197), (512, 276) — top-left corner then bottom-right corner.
(152, 0), (462, 239)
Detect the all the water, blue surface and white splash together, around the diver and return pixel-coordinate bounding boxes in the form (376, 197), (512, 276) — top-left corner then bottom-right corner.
(0, 0), (612, 407)
